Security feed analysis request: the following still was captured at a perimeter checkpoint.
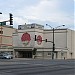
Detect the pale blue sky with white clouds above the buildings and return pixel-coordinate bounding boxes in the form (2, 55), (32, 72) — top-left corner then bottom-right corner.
(0, 0), (75, 30)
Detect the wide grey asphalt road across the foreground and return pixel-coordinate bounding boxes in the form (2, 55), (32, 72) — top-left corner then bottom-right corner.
(0, 59), (75, 75)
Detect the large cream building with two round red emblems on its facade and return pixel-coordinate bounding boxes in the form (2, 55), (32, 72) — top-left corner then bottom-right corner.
(13, 23), (75, 59)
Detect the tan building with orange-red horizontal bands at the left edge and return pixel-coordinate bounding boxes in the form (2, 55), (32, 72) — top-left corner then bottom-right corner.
(0, 25), (16, 54)
